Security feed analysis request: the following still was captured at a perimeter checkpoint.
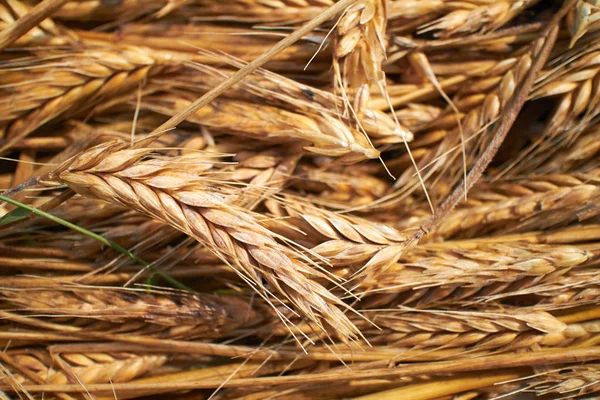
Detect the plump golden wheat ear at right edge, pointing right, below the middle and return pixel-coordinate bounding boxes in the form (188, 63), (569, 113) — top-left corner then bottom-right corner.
(364, 241), (597, 307)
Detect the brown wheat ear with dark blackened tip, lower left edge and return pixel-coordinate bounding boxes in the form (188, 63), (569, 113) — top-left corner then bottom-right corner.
(0, 287), (260, 337)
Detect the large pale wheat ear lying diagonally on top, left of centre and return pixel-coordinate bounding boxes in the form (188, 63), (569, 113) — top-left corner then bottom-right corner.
(54, 142), (356, 339)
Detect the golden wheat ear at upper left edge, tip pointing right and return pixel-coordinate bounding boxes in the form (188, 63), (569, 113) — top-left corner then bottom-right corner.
(0, 47), (169, 151)
